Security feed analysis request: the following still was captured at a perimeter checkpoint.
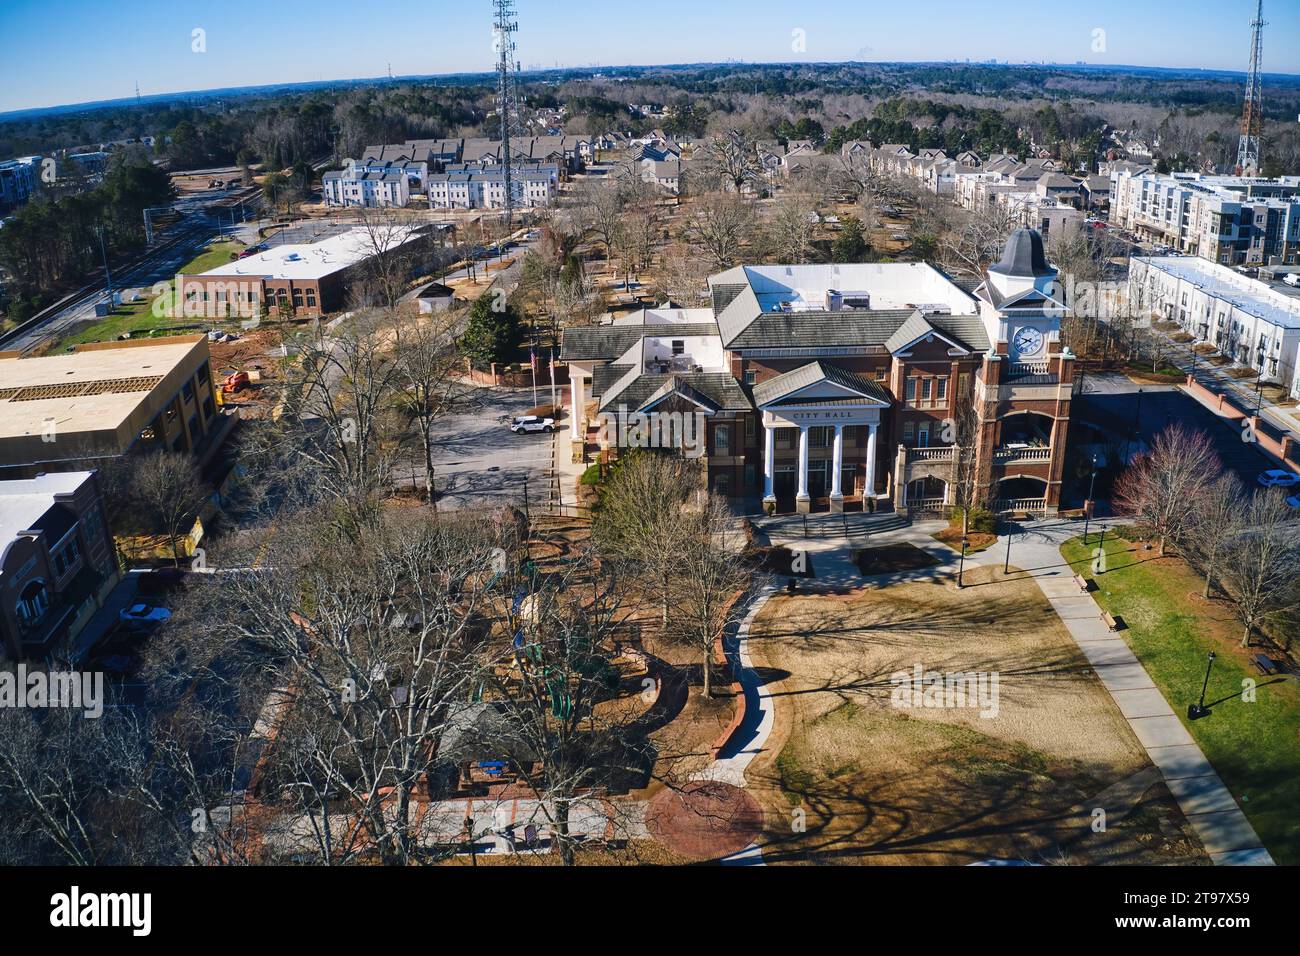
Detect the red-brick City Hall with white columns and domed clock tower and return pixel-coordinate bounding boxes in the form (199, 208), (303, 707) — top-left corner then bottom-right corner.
(560, 229), (1074, 514)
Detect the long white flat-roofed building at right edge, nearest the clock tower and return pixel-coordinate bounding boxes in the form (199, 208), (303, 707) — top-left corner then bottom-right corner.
(1128, 256), (1300, 398)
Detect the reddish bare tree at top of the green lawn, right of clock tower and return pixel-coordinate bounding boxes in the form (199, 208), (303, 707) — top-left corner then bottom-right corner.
(1114, 425), (1222, 557)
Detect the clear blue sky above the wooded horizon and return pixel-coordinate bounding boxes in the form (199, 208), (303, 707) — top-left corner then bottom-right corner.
(0, 0), (1300, 112)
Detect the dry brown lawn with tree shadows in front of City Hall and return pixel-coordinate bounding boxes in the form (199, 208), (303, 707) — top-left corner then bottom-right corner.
(748, 567), (1205, 864)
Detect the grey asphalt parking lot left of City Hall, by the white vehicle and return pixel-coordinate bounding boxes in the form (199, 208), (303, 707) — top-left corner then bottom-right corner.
(418, 388), (556, 507)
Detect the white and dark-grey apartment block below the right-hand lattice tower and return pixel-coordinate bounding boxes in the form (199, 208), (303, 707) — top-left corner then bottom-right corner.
(1110, 168), (1300, 265)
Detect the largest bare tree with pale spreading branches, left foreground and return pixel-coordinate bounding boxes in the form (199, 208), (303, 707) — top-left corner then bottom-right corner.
(203, 512), (515, 865)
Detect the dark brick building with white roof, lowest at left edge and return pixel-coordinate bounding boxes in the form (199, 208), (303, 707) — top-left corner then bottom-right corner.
(0, 471), (118, 659)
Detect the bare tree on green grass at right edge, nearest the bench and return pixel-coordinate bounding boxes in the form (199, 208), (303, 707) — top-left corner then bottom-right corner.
(1221, 488), (1300, 648)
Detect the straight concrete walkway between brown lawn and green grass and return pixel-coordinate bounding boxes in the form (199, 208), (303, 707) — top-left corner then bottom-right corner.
(989, 522), (1273, 866)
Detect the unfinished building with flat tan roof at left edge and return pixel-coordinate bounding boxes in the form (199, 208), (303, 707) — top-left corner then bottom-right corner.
(0, 334), (226, 479)
